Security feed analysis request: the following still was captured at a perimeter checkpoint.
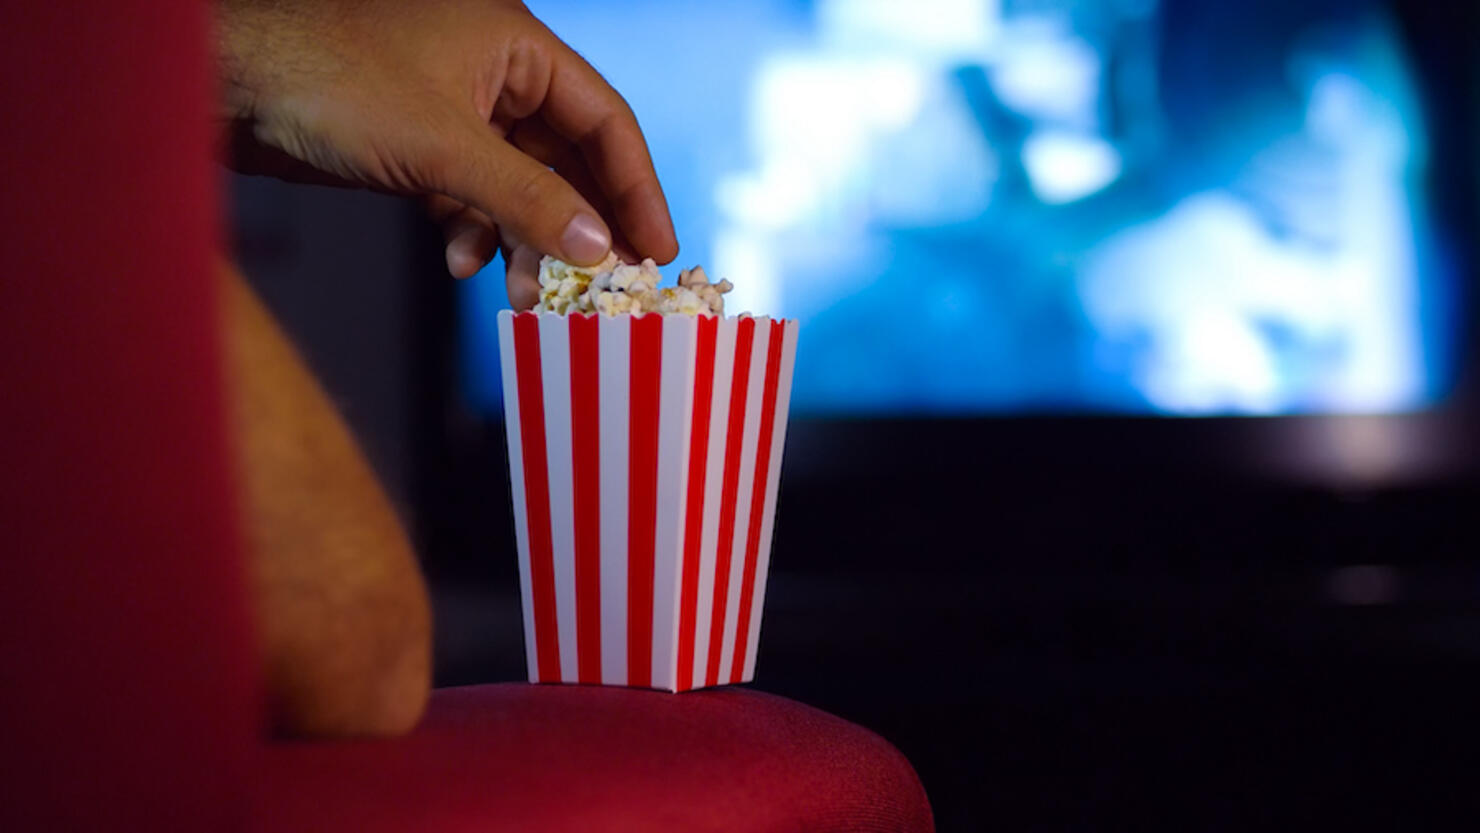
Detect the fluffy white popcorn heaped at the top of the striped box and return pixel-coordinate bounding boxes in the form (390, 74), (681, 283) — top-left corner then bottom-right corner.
(534, 254), (734, 317)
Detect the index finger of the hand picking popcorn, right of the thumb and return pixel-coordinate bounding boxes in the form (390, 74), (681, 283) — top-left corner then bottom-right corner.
(540, 47), (678, 263)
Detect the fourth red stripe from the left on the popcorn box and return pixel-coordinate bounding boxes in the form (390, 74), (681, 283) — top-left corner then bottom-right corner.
(678, 315), (719, 691)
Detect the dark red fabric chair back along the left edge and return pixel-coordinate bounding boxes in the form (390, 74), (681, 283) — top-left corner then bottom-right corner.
(0, 0), (258, 832)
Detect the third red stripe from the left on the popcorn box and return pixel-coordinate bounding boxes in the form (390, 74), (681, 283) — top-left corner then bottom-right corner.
(628, 315), (663, 687)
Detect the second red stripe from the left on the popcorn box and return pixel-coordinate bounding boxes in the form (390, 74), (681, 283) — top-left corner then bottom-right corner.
(570, 315), (601, 685)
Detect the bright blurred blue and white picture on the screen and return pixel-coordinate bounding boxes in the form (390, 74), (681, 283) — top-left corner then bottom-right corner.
(465, 0), (1444, 414)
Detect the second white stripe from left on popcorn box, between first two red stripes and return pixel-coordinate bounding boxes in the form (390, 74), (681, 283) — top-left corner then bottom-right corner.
(540, 312), (579, 682)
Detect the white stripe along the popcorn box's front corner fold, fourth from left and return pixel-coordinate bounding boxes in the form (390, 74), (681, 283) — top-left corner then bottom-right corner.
(653, 315), (699, 691)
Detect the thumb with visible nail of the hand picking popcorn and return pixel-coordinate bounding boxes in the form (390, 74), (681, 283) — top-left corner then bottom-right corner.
(435, 115), (611, 266)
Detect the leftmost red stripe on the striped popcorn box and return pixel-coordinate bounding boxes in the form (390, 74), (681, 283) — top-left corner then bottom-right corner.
(514, 315), (559, 682)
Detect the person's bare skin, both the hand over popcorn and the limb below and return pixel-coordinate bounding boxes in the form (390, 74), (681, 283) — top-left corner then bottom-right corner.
(216, 0), (678, 737)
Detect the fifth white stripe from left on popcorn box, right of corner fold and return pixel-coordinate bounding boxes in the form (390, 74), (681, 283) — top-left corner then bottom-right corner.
(693, 318), (736, 687)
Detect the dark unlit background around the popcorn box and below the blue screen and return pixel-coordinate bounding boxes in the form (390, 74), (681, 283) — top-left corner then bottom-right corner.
(229, 3), (1480, 830)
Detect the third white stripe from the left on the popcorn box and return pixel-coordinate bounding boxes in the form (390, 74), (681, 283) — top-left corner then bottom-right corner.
(596, 315), (632, 685)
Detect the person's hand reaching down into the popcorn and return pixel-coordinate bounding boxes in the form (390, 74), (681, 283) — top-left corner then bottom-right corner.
(218, 0), (678, 309)
